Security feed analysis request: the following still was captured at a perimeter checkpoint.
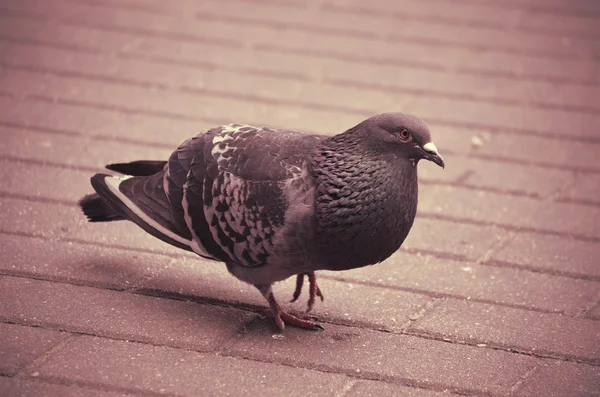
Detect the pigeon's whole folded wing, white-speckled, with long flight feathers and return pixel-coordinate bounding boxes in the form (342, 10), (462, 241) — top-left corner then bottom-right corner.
(92, 125), (322, 267)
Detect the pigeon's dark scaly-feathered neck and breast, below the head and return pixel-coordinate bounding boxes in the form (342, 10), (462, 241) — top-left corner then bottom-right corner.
(312, 134), (418, 270)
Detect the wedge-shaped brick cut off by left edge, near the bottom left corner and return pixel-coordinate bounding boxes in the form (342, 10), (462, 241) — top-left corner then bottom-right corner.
(0, 322), (69, 374)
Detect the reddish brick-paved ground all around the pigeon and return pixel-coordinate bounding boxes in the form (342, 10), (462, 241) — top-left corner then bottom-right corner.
(0, 0), (600, 396)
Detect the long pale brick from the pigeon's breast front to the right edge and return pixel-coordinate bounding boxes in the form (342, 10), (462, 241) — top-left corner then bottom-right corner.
(419, 185), (600, 238)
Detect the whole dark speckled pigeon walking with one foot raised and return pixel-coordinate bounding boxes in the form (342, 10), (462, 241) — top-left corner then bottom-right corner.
(79, 113), (445, 331)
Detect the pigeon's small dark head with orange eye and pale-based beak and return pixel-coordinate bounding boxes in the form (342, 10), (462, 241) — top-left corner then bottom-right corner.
(363, 113), (445, 168)
